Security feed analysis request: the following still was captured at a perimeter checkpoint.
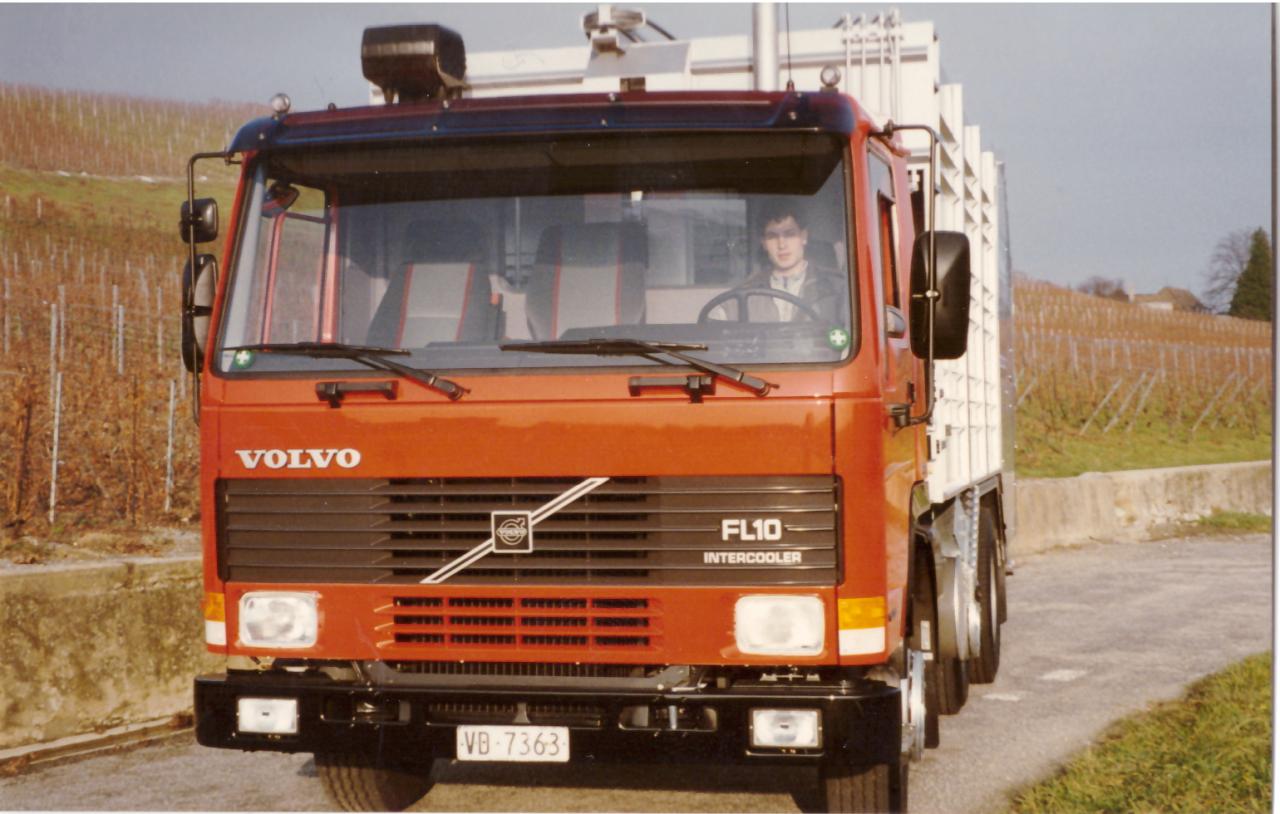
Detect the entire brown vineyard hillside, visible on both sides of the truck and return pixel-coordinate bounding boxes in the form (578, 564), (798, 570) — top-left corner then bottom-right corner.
(0, 83), (1271, 561)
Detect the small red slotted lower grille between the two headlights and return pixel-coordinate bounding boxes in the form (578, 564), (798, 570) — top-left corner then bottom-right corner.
(376, 596), (662, 653)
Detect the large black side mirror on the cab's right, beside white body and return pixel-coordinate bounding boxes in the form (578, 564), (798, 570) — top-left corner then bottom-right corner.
(911, 232), (969, 358)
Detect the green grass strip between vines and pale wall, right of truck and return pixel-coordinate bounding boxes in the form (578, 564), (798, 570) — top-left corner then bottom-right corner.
(1014, 415), (1271, 477)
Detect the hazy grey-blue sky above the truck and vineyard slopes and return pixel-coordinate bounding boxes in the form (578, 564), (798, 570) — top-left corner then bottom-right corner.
(0, 3), (1271, 293)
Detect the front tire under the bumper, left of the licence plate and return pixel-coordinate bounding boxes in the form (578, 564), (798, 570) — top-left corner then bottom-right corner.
(316, 753), (433, 811)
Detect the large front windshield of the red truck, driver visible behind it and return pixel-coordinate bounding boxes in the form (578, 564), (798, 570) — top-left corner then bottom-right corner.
(215, 133), (856, 372)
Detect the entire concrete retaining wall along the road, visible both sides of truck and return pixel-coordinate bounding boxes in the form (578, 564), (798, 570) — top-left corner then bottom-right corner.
(0, 462), (1271, 750)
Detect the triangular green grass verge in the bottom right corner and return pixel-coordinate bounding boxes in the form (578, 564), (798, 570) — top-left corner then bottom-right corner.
(1011, 653), (1271, 814)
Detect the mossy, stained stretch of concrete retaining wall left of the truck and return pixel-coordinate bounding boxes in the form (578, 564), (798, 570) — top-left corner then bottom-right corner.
(0, 558), (218, 749)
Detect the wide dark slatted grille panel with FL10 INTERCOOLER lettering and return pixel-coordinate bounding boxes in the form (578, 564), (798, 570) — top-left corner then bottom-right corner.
(218, 476), (838, 586)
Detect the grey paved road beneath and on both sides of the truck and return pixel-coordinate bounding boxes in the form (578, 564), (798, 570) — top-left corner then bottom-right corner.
(0, 535), (1271, 814)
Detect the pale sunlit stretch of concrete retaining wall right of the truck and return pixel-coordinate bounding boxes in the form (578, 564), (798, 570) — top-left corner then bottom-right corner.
(1011, 461), (1271, 557)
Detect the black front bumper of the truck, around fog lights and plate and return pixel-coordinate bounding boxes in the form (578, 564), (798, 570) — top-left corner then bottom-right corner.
(195, 672), (901, 765)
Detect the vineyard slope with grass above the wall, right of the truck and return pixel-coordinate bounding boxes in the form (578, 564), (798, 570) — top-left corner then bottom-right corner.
(1014, 275), (1272, 476)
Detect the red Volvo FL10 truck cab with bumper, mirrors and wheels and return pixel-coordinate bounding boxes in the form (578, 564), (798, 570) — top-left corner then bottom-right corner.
(182, 20), (1007, 810)
